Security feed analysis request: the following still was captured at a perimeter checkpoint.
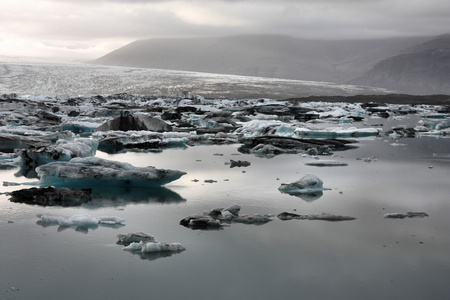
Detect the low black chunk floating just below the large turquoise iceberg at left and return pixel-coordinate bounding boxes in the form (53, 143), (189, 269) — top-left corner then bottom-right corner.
(9, 187), (92, 207)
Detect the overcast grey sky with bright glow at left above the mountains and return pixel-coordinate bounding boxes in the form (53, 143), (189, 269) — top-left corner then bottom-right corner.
(0, 0), (450, 59)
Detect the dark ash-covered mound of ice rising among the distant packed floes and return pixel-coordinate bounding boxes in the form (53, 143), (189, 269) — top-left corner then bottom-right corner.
(94, 114), (172, 132)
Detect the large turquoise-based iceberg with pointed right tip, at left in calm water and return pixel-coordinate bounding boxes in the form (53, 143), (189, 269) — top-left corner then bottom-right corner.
(36, 156), (186, 188)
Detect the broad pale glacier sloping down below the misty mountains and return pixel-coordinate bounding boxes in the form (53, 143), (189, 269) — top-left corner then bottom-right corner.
(0, 62), (388, 99)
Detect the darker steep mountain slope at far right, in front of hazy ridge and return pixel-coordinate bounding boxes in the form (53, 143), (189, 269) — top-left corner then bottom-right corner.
(350, 34), (450, 94)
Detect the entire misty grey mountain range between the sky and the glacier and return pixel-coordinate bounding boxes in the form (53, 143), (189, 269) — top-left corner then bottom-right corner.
(93, 35), (450, 94)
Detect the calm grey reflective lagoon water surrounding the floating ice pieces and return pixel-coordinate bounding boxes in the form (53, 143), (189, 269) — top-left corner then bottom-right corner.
(0, 123), (450, 299)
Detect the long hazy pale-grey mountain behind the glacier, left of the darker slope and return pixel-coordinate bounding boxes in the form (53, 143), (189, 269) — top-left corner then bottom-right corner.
(93, 35), (429, 83)
